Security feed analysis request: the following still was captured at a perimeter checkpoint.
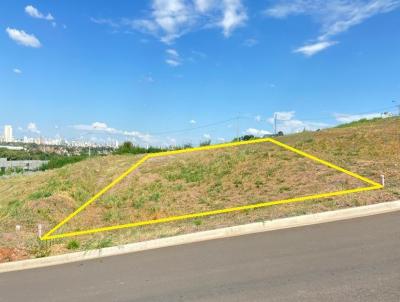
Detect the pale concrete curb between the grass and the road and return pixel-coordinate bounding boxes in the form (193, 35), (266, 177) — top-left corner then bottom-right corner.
(0, 200), (400, 273)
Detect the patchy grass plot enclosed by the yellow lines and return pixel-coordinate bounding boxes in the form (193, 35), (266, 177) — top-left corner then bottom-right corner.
(57, 142), (368, 236)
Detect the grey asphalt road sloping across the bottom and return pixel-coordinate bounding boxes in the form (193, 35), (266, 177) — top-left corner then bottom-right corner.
(0, 212), (400, 302)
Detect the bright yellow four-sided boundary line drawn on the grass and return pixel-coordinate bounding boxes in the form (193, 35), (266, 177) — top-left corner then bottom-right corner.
(40, 138), (383, 240)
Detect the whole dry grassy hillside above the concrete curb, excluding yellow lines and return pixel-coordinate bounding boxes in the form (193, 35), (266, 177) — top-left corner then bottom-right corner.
(0, 118), (400, 261)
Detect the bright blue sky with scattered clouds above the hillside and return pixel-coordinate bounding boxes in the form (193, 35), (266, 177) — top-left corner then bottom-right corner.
(0, 0), (400, 145)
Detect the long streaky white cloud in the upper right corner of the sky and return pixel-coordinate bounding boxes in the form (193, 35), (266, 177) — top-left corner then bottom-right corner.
(266, 0), (400, 55)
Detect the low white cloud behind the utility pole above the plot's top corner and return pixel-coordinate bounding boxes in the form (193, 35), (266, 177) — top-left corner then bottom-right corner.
(267, 111), (329, 133)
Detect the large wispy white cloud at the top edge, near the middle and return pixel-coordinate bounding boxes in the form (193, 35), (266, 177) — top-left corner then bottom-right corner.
(110, 0), (247, 44)
